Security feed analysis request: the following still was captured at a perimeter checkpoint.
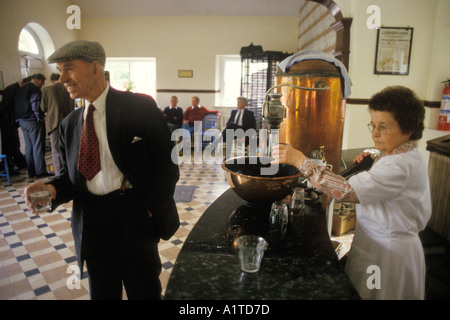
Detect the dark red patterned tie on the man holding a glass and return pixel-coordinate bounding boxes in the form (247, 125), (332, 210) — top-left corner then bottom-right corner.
(78, 104), (101, 181)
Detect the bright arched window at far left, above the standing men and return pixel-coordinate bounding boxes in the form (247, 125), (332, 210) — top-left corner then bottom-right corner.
(18, 26), (44, 78)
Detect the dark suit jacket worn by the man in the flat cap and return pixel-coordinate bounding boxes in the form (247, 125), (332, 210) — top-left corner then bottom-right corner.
(49, 88), (180, 265)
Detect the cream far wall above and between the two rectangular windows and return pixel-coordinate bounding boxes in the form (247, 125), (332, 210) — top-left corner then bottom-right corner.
(80, 16), (297, 109)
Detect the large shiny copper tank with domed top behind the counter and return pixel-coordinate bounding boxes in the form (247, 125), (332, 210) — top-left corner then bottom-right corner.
(275, 60), (345, 173)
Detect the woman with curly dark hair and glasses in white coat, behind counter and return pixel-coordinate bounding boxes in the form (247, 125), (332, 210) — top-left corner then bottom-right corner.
(273, 86), (431, 299)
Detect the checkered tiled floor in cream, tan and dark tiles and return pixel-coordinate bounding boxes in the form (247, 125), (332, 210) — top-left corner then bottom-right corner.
(0, 150), (351, 300)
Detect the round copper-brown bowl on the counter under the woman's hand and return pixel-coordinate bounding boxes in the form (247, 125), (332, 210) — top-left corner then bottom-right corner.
(222, 156), (301, 203)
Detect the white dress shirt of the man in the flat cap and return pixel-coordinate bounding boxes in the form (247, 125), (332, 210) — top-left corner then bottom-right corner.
(83, 86), (123, 195)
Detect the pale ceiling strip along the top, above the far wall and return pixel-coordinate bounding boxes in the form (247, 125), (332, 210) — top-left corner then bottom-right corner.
(72, 0), (305, 17)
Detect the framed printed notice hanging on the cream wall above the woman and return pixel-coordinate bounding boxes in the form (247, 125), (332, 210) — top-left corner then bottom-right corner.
(374, 27), (413, 75)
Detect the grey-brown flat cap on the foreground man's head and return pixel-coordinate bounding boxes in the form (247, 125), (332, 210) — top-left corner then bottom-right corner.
(47, 40), (106, 66)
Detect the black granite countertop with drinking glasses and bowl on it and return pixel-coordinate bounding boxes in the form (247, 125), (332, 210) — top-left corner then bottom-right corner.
(164, 189), (359, 300)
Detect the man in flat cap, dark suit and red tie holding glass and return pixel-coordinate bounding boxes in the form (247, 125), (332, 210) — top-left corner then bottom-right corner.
(24, 40), (179, 299)
